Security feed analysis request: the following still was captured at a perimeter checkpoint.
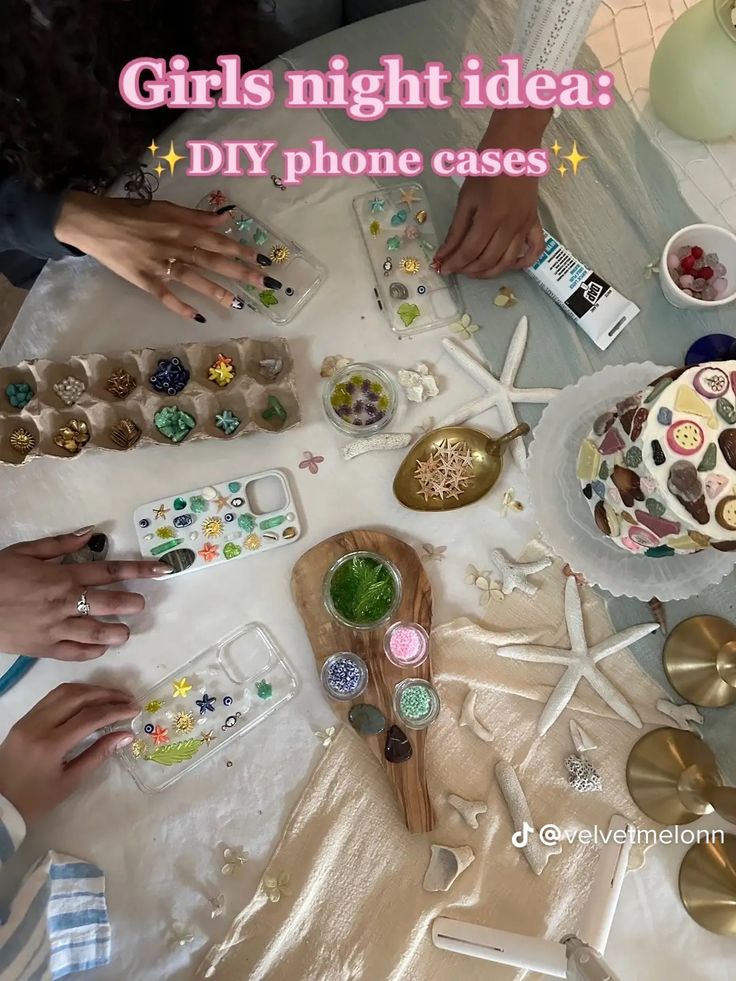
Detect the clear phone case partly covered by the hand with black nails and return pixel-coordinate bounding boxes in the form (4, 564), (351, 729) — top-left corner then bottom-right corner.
(197, 190), (327, 326)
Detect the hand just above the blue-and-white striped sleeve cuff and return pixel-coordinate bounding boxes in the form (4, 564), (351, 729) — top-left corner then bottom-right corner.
(0, 685), (140, 823)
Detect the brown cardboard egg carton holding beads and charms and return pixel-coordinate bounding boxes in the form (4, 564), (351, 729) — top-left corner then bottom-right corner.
(0, 337), (301, 466)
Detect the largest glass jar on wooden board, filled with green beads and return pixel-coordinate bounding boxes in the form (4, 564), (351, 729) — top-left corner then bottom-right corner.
(322, 551), (401, 630)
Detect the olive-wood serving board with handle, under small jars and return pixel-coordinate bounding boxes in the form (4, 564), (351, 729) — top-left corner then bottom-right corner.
(291, 529), (434, 834)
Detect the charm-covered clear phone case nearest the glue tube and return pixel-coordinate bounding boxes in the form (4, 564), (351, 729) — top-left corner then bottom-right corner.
(353, 183), (461, 336)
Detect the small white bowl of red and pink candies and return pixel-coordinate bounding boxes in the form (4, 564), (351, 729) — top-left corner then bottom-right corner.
(659, 224), (736, 309)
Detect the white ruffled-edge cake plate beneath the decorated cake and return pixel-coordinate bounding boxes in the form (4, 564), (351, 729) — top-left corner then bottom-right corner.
(528, 361), (736, 602)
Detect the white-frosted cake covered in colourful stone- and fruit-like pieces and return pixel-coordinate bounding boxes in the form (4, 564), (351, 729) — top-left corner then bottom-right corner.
(577, 361), (736, 558)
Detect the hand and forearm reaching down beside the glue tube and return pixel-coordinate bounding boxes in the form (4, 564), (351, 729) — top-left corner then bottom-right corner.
(435, 109), (551, 279)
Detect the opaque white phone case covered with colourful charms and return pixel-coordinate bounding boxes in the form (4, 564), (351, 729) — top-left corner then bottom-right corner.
(133, 470), (302, 578)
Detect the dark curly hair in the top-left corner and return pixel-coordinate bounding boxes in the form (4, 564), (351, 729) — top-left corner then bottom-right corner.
(0, 0), (287, 191)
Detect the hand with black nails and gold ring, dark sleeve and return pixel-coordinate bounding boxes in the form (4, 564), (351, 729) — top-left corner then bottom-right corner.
(54, 191), (282, 323)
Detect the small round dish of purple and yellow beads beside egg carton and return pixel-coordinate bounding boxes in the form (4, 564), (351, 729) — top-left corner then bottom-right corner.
(323, 364), (398, 439)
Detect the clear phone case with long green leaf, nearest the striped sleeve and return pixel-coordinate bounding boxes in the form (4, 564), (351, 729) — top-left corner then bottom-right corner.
(120, 623), (299, 793)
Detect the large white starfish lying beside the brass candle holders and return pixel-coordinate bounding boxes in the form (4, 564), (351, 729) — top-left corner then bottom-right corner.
(498, 577), (659, 735)
